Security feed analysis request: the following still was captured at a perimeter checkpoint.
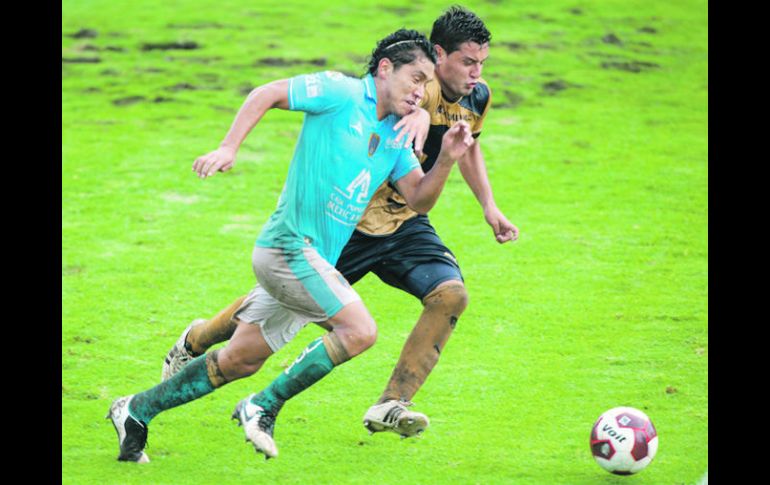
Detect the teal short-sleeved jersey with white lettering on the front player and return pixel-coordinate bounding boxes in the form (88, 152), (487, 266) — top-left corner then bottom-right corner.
(256, 71), (420, 265)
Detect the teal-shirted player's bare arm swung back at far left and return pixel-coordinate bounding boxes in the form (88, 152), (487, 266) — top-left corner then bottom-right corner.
(192, 79), (289, 178)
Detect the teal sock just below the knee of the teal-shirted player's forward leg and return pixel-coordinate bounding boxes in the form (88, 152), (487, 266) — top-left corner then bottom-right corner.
(251, 337), (334, 415)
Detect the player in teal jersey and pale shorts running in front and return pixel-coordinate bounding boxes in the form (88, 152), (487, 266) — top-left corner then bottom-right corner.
(108, 29), (473, 462)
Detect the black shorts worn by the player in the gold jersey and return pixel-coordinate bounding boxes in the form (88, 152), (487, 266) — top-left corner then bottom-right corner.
(337, 215), (463, 300)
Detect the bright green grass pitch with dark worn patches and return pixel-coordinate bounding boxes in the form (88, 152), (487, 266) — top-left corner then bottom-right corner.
(62, 0), (708, 485)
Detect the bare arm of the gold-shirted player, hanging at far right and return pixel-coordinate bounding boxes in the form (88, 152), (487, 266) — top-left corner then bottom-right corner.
(457, 139), (519, 244)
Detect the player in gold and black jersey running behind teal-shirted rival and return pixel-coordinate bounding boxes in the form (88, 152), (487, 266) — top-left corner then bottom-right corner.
(162, 6), (519, 436)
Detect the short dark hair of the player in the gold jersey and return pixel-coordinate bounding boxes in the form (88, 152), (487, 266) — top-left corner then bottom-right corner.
(430, 5), (492, 54)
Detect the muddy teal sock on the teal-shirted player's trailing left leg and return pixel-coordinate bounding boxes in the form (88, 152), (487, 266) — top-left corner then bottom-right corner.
(128, 354), (214, 425)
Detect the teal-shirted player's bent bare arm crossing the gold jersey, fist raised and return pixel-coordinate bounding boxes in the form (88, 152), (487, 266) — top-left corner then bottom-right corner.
(396, 121), (473, 214)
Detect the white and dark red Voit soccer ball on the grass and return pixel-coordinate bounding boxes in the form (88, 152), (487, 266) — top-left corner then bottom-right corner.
(591, 407), (658, 475)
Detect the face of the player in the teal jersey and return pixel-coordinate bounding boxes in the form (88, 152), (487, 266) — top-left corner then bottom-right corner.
(388, 56), (435, 116)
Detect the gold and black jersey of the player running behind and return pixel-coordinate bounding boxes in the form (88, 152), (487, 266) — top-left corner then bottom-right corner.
(356, 78), (492, 236)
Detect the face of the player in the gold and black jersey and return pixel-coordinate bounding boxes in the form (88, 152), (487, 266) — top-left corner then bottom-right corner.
(436, 42), (489, 99)
